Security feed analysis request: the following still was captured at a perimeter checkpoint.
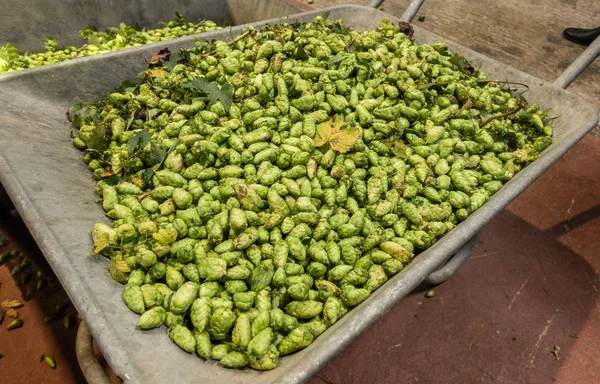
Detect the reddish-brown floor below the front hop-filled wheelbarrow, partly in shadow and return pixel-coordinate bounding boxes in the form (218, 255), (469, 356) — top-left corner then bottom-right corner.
(0, 136), (600, 384)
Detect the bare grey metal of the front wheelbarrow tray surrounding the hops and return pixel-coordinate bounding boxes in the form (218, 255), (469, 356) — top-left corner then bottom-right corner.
(0, 6), (598, 384)
